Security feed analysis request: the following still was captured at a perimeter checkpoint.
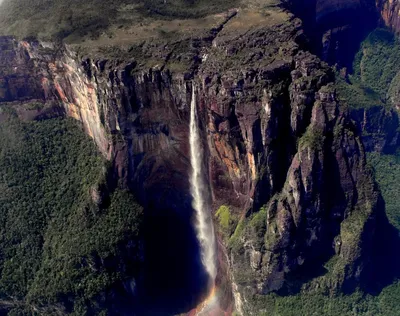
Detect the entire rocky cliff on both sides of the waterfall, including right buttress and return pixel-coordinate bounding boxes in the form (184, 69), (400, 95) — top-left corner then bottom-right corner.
(0, 1), (390, 315)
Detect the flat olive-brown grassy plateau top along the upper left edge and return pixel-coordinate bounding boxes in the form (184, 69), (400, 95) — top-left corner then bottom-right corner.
(0, 0), (280, 46)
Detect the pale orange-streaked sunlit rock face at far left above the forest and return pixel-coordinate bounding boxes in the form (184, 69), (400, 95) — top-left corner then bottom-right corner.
(0, 37), (110, 157)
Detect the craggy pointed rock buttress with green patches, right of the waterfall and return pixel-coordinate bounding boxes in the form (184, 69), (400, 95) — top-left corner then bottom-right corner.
(233, 82), (379, 313)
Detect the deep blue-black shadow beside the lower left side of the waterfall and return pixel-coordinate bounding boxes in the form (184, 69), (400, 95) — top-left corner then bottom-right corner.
(130, 205), (209, 316)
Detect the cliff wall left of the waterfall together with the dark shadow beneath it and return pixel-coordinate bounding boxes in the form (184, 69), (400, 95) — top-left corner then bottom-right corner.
(0, 38), (212, 313)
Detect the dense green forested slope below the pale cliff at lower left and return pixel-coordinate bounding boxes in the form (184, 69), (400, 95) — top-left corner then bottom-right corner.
(0, 108), (142, 315)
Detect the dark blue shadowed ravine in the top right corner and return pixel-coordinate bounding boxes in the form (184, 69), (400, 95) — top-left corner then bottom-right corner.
(283, 0), (400, 68)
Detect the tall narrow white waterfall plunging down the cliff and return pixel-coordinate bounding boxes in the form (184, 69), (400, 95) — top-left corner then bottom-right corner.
(189, 85), (217, 285)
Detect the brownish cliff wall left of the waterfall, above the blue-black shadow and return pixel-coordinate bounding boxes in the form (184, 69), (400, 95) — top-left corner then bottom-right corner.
(0, 38), (189, 205)
